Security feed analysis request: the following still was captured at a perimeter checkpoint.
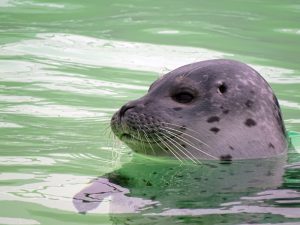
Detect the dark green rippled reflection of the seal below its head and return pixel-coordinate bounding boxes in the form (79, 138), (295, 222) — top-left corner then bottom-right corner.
(73, 152), (300, 224)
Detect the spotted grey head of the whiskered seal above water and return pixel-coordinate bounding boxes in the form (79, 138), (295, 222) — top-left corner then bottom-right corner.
(111, 60), (287, 161)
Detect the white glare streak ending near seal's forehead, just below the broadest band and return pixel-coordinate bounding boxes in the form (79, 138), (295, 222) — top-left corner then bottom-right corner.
(0, 60), (148, 96)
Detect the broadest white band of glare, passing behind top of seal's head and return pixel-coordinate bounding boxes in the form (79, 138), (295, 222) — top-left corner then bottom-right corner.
(0, 33), (300, 83)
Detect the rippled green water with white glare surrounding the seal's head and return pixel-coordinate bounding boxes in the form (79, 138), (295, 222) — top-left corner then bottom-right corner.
(0, 0), (300, 225)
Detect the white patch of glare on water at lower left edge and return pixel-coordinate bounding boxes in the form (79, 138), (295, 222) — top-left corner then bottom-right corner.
(0, 173), (92, 211)
